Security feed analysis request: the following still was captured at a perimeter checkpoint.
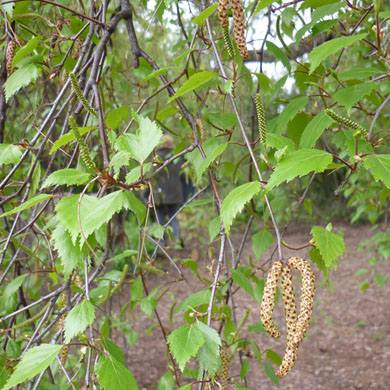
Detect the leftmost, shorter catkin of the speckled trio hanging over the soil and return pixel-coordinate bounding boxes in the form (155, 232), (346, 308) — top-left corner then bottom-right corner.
(260, 260), (282, 338)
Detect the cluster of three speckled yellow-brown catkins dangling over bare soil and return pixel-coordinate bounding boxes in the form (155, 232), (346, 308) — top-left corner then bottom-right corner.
(260, 257), (315, 378)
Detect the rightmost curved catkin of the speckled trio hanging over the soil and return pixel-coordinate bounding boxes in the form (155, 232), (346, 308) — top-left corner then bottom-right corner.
(287, 257), (315, 347)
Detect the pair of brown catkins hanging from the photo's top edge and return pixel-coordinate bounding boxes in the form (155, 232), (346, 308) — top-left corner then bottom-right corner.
(218, 0), (248, 58)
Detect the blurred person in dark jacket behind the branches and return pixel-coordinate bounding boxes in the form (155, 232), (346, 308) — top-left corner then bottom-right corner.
(153, 135), (194, 246)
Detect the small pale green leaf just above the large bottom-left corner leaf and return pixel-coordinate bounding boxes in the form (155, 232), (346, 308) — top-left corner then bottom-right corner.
(64, 300), (95, 343)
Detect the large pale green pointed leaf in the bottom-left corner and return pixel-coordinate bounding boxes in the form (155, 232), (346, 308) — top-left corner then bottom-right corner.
(2, 344), (62, 390)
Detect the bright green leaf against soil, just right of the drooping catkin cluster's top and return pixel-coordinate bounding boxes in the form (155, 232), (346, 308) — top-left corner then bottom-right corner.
(310, 226), (345, 268)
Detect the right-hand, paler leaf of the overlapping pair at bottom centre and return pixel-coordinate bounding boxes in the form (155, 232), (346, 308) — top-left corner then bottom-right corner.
(195, 321), (221, 377)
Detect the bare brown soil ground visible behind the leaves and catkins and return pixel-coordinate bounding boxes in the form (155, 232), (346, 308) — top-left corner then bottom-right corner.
(116, 225), (390, 390)
